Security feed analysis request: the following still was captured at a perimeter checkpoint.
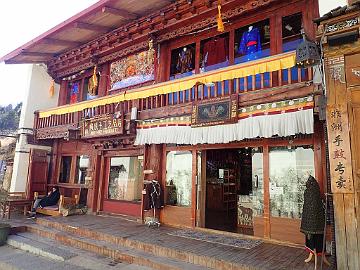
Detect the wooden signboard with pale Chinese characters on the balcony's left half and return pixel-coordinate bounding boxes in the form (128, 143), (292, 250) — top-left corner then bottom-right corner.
(81, 114), (124, 138)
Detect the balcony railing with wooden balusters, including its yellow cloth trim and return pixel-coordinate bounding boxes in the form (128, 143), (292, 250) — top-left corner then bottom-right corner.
(35, 53), (312, 132)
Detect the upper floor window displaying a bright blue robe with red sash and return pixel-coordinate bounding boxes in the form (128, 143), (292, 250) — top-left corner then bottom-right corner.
(234, 19), (270, 64)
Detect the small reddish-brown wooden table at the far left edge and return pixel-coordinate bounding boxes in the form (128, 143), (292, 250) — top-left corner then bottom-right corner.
(1, 192), (33, 219)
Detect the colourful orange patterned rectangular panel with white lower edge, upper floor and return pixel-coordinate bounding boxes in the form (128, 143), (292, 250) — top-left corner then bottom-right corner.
(110, 49), (155, 90)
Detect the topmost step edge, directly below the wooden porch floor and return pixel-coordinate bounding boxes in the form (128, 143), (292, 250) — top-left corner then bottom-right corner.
(36, 218), (248, 270)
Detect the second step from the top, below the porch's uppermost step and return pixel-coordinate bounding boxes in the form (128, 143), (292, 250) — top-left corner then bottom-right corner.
(27, 223), (209, 270)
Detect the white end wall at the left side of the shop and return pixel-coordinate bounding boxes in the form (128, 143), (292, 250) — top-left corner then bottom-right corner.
(10, 65), (60, 192)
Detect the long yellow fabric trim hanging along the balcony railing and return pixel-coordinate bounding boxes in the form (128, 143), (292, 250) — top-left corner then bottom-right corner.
(39, 52), (295, 118)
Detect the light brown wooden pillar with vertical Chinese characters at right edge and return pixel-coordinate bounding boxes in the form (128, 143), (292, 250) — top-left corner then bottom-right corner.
(325, 53), (360, 270)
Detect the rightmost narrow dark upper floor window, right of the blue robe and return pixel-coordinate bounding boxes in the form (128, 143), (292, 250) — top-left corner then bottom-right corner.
(282, 13), (303, 52)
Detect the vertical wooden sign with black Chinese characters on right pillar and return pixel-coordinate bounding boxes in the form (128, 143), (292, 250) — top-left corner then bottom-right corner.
(327, 104), (354, 193)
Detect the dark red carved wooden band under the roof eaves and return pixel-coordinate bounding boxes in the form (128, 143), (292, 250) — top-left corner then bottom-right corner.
(48, 0), (278, 78)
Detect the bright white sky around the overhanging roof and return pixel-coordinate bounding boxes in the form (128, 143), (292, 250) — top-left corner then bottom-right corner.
(0, 0), (346, 105)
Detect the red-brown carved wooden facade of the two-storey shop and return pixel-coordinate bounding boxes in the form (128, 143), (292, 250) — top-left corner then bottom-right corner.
(2, 0), (326, 249)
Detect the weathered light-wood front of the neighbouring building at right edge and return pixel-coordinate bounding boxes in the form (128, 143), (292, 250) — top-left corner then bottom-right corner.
(318, 1), (360, 269)
